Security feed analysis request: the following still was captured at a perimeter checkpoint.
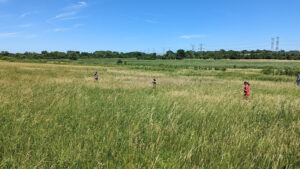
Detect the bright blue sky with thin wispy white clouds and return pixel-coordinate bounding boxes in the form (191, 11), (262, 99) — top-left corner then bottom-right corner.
(0, 0), (300, 53)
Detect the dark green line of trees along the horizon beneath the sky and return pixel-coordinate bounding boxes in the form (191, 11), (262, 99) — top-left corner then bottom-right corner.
(0, 49), (300, 60)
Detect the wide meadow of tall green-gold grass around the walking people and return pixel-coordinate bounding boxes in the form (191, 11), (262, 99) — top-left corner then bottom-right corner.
(0, 59), (300, 168)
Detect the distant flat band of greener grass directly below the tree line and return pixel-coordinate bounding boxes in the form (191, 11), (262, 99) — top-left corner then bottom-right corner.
(4, 58), (300, 69)
